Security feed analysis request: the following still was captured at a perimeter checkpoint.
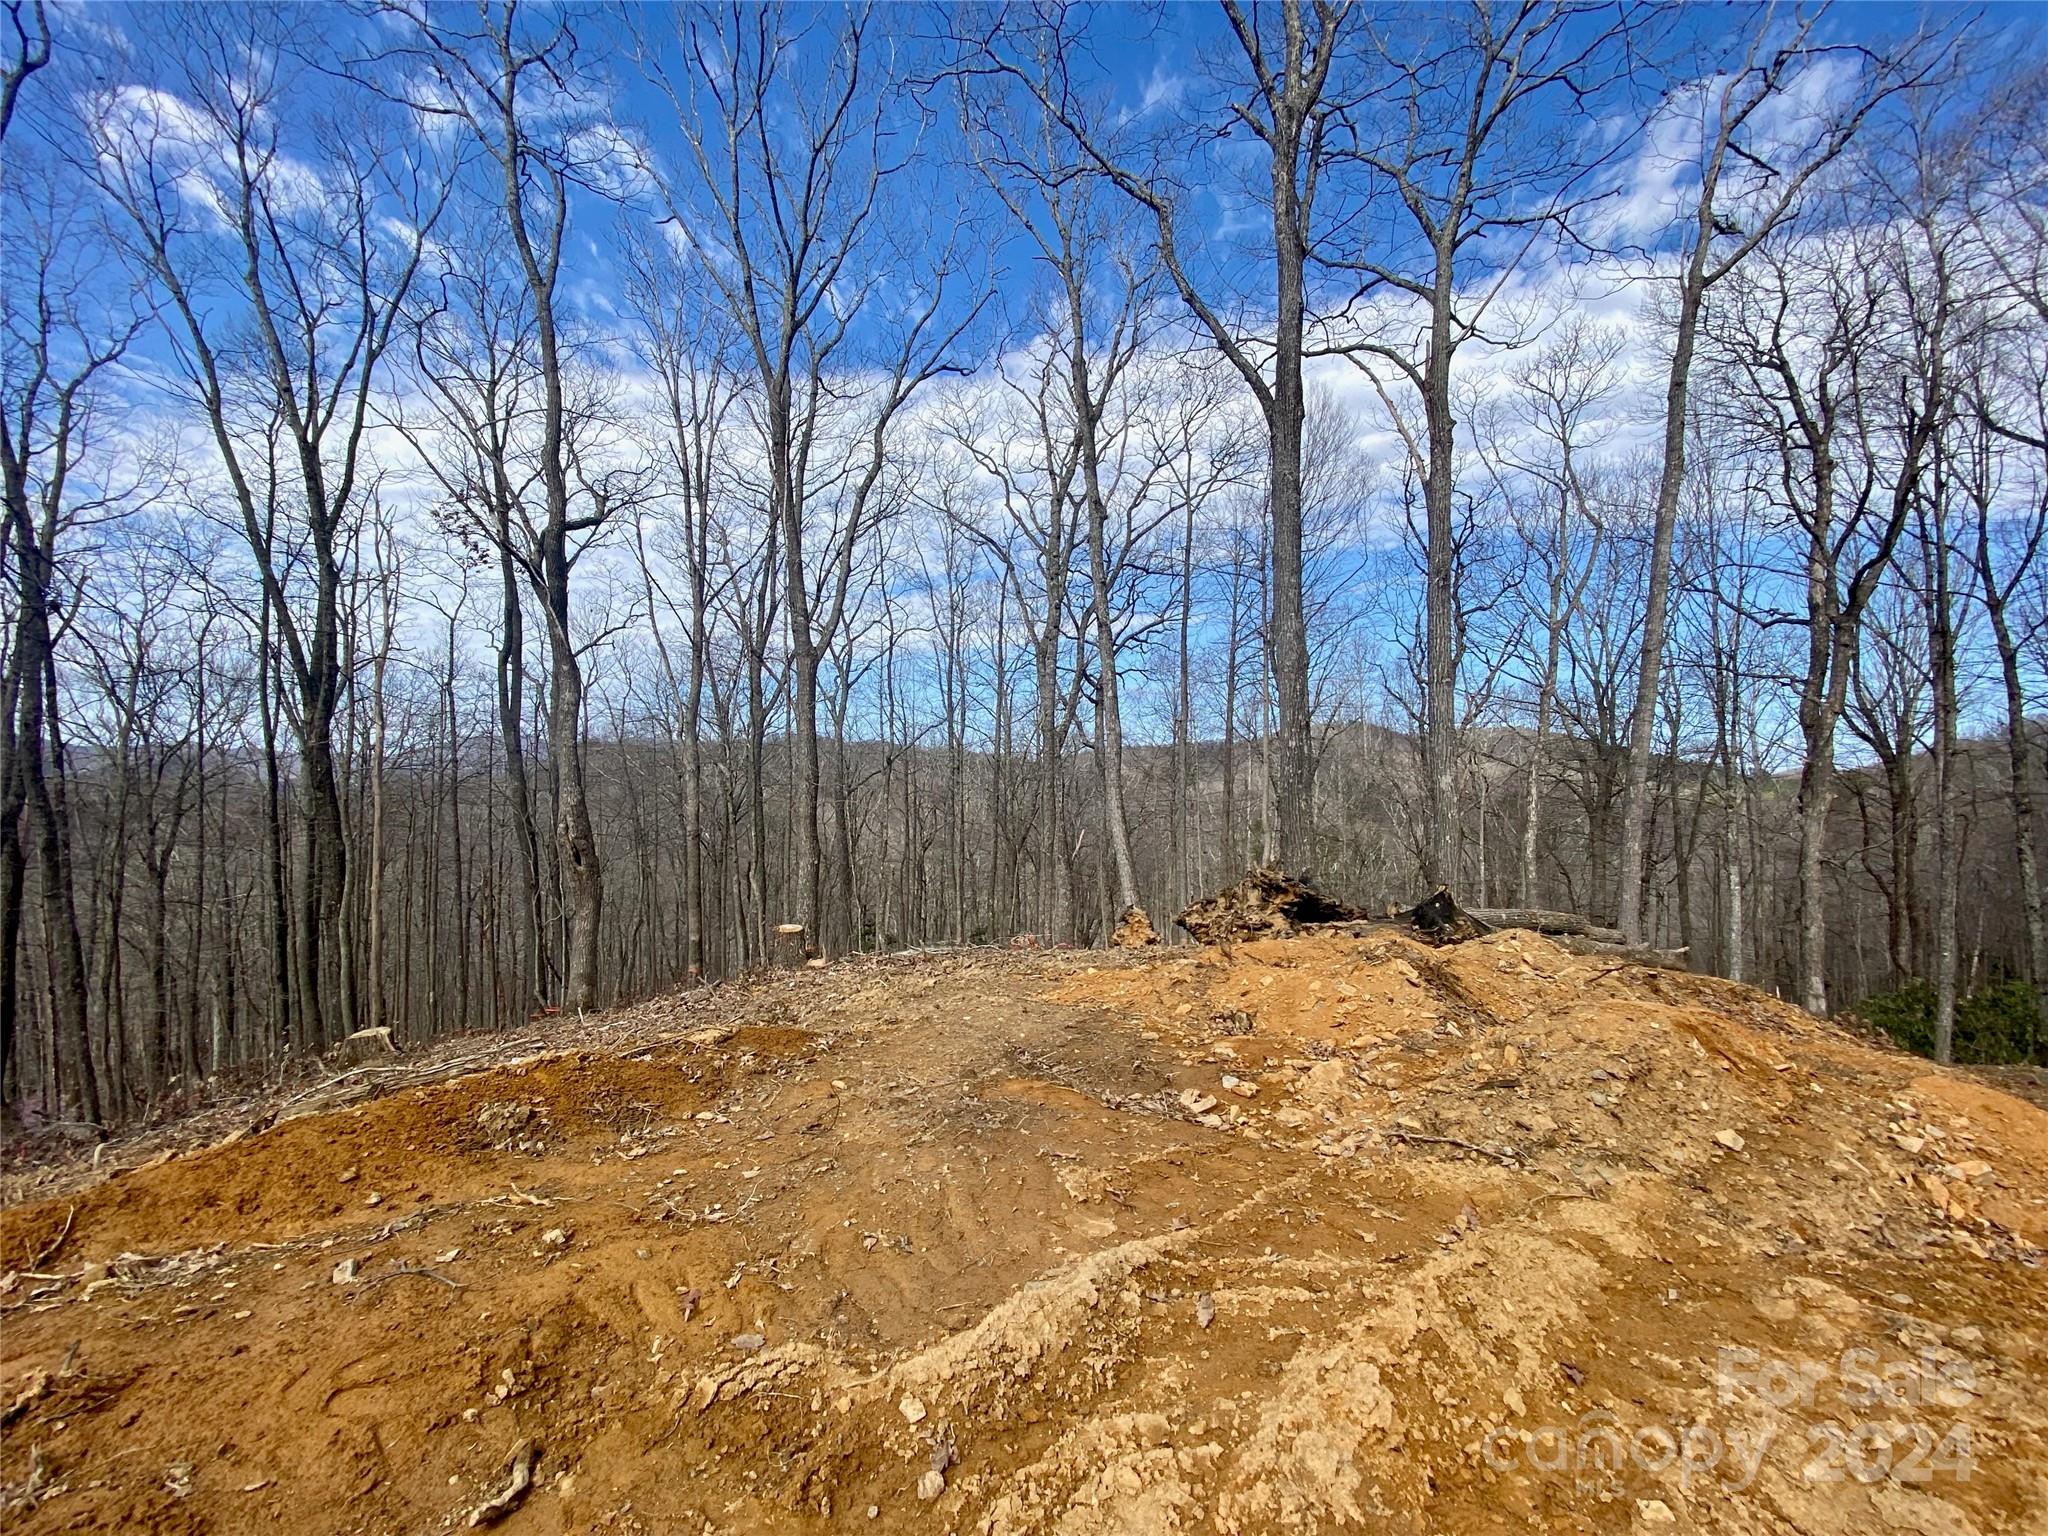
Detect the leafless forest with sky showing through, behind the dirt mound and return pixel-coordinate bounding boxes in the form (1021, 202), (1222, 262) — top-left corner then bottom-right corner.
(0, 0), (2048, 1126)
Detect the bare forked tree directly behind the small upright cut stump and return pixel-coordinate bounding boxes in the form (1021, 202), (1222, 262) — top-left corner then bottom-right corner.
(651, 6), (973, 948)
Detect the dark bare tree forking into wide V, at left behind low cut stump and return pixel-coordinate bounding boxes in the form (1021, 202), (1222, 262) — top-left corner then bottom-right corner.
(92, 8), (449, 1040)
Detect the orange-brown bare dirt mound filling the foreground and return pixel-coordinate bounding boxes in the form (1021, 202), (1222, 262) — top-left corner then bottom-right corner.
(0, 932), (2048, 1536)
